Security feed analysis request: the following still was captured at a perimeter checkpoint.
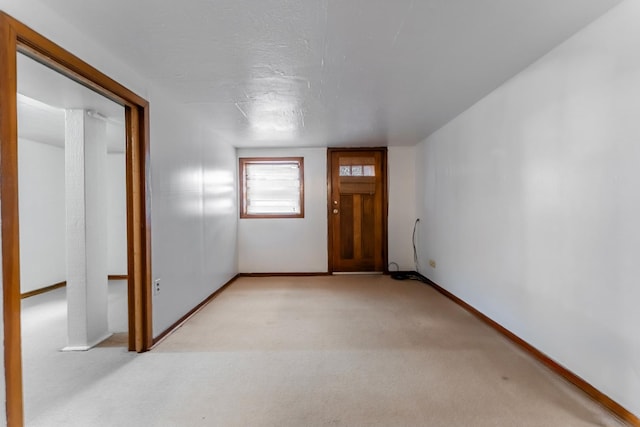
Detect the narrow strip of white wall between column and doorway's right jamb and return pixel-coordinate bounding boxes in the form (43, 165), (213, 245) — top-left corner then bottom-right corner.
(107, 153), (127, 276)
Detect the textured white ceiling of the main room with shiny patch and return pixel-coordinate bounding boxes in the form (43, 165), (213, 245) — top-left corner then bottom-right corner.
(33, 0), (620, 147)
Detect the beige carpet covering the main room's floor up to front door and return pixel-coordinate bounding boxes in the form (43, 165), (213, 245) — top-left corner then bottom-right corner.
(25, 276), (623, 426)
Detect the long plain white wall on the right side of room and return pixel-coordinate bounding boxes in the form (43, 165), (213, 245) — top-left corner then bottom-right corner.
(417, 0), (640, 415)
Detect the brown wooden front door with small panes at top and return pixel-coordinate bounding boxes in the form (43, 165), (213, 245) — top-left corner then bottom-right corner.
(327, 148), (387, 272)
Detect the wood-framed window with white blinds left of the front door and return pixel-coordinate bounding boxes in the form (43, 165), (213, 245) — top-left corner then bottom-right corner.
(240, 157), (304, 218)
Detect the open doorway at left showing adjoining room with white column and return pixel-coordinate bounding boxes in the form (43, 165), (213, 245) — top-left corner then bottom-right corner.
(17, 54), (129, 422)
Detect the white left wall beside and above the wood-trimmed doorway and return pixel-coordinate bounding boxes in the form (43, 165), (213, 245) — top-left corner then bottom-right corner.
(0, 0), (237, 348)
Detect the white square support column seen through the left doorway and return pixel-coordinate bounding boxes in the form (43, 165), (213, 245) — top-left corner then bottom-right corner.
(64, 110), (110, 351)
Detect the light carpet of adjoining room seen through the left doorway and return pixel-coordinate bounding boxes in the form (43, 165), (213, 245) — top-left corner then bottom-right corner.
(21, 280), (135, 425)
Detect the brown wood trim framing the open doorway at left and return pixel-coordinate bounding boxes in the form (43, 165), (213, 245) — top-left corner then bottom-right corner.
(0, 11), (153, 427)
